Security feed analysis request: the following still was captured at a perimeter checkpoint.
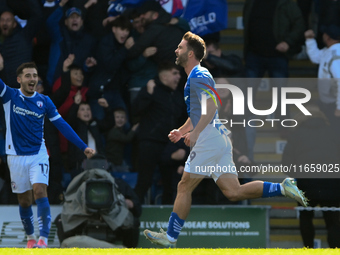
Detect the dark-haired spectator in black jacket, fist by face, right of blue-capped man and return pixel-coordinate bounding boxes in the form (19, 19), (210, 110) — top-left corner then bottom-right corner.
(88, 16), (134, 120)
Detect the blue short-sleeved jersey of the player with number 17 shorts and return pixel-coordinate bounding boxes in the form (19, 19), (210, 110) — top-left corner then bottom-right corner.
(0, 79), (61, 155)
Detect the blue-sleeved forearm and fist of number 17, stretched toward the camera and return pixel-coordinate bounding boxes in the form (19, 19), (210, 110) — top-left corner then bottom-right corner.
(50, 117), (96, 158)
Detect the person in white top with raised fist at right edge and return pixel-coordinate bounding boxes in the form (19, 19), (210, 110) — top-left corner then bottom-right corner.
(305, 24), (340, 134)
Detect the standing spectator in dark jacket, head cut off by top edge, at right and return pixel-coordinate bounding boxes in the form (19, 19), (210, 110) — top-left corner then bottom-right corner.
(243, 0), (305, 160)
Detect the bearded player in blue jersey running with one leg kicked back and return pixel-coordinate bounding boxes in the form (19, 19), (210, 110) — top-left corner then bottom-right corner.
(144, 32), (307, 248)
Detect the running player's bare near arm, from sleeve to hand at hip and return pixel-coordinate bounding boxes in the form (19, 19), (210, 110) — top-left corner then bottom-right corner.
(184, 98), (217, 146)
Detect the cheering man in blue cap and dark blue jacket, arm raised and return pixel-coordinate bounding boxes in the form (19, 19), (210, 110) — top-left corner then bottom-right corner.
(47, 0), (96, 86)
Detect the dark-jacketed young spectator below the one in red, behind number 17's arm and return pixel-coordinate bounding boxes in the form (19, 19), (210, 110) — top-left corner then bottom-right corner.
(67, 101), (105, 178)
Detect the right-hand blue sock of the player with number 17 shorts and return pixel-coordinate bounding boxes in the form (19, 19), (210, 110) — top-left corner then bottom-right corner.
(35, 197), (51, 238)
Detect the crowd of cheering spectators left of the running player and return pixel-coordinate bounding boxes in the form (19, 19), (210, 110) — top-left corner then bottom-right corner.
(0, 0), (190, 204)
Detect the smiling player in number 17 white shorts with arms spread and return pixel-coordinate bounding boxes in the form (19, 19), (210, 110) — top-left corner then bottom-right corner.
(0, 63), (95, 248)
